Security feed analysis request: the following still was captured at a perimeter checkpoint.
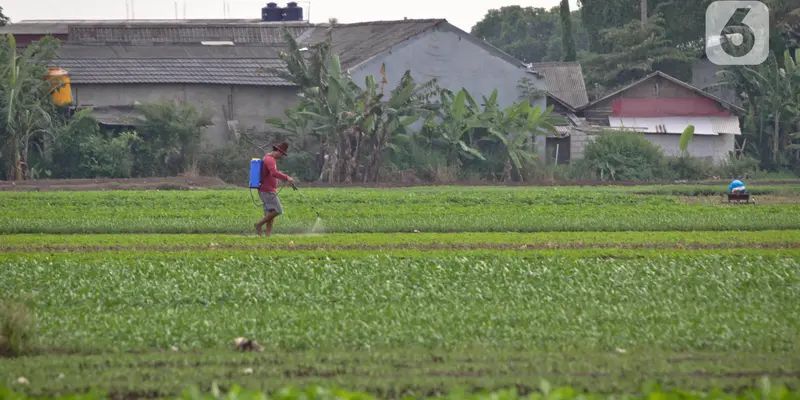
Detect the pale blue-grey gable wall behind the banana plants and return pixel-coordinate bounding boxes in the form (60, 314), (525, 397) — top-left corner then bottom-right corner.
(350, 24), (547, 158)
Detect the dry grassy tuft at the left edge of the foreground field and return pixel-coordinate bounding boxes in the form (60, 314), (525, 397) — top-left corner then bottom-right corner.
(0, 300), (35, 357)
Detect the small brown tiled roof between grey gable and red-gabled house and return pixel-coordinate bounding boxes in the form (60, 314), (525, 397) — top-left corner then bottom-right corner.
(529, 62), (589, 108)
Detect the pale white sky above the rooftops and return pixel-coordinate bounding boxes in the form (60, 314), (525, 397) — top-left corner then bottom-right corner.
(0, 0), (577, 32)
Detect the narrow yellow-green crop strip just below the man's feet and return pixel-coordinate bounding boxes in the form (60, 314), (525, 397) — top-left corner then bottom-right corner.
(0, 230), (800, 251)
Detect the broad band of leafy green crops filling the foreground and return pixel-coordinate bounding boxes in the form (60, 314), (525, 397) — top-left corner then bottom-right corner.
(0, 250), (800, 351)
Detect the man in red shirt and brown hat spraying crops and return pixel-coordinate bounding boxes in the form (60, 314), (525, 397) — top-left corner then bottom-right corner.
(256, 142), (294, 236)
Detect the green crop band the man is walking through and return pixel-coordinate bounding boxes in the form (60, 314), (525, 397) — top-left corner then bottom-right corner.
(0, 188), (800, 234)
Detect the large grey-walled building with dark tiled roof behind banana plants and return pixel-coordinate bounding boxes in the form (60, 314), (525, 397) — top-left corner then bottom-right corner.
(1, 19), (546, 148)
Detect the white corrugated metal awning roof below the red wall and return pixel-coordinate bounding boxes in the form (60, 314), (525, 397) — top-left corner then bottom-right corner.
(608, 116), (741, 136)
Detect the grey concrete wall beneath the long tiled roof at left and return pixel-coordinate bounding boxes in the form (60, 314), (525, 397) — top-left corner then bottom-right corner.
(72, 84), (298, 147)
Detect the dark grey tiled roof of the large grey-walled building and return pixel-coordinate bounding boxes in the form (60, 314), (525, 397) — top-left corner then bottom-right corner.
(54, 19), (444, 86)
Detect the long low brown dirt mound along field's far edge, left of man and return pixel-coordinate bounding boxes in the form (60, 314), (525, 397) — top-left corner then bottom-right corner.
(0, 176), (235, 192)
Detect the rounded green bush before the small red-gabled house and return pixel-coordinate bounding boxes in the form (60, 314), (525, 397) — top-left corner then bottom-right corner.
(580, 131), (670, 181)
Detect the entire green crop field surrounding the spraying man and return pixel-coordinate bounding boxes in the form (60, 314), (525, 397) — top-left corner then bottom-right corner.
(0, 185), (800, 400)
